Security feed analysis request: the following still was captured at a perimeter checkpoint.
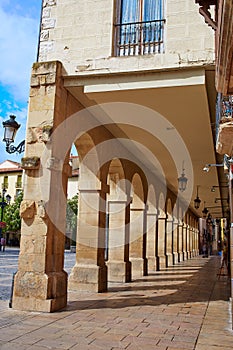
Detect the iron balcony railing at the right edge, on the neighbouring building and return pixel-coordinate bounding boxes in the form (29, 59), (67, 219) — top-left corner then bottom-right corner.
(216, 93), (233, 137)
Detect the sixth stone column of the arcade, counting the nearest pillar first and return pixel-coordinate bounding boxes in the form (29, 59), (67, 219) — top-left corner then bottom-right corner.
(157, 210), (167, 270)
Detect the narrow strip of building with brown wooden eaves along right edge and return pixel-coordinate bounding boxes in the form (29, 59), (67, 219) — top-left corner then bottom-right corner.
(196, 0), (233, 322)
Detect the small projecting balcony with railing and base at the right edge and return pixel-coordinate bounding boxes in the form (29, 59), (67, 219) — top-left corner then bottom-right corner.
(216, 93), (233, 156)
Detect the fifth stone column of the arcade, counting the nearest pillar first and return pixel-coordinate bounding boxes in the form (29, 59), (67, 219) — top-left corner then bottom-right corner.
(146, 209), (157, 272)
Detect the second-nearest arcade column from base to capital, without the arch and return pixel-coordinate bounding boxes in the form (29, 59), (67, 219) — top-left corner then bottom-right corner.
(69, 180), (109, 292)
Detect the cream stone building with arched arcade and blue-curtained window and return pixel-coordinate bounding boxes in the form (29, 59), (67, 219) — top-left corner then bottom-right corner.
(10, 0), (224, 312)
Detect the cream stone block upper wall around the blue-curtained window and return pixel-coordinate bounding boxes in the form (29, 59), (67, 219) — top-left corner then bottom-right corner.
(39, 0), (214, 75)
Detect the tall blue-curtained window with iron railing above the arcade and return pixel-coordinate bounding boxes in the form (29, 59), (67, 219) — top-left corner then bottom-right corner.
(115, 0), (165, 56)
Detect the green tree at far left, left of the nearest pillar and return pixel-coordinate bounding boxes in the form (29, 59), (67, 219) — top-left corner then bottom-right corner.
(3, 192), (23, 232)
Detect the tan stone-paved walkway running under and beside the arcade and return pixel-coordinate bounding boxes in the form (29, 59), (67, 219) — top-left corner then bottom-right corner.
(0, 257), (233, 350)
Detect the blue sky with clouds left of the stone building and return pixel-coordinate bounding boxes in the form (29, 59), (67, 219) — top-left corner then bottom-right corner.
(0, 0), (42, 162)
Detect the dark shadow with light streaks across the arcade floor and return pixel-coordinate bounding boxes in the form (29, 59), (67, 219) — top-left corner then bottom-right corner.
(63, 256), (230, 311)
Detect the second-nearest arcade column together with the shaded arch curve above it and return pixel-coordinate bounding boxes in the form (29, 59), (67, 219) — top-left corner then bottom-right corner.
(69, 133), (107, 292)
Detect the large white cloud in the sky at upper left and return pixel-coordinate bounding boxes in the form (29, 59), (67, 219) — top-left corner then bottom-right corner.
(0, 0), (39, 102)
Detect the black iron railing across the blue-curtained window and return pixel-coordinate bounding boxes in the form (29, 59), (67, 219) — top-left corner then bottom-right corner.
(115, 19), (165, 56)
